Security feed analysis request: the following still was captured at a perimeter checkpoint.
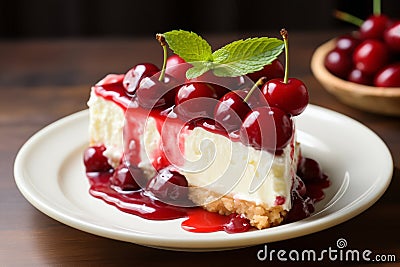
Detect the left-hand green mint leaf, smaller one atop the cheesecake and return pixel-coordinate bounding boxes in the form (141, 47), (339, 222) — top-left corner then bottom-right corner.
(164, 30), (212, 63)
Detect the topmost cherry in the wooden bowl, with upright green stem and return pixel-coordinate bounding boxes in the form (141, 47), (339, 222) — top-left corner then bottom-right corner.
(359, 15), (391, 40)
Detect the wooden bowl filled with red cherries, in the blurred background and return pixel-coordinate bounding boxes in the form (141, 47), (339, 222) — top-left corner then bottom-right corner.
(311, 1), (400, 116)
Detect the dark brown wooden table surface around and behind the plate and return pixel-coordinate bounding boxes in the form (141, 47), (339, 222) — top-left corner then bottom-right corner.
(0, 32), (400, 266)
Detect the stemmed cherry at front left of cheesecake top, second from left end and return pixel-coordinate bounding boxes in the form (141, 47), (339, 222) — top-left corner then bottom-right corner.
(136, 74), (177, 109)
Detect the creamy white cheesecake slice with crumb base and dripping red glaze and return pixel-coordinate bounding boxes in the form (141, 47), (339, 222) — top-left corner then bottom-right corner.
(88, 75), (300, 229)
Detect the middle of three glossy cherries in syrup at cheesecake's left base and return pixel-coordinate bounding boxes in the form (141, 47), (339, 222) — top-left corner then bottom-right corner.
(110, 164), (144, 191)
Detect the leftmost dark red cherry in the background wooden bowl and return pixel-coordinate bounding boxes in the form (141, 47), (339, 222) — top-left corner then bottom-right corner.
(324, 49), (353, 79)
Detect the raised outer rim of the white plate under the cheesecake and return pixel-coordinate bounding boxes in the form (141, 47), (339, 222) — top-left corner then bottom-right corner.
(14, 104), (394, 251)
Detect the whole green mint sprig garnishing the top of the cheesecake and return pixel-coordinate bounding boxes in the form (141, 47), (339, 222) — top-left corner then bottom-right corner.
(164, 30), (284, 79)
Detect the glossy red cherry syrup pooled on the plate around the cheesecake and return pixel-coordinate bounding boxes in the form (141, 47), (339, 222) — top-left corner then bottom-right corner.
(85, 147), (330, 233)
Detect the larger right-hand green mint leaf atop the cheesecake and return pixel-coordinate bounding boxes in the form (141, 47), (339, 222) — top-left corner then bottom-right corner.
(212, 37), (284, 77)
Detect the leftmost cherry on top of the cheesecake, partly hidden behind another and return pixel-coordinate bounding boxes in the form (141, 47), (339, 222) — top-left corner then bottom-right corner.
(123, 63), (160, 96)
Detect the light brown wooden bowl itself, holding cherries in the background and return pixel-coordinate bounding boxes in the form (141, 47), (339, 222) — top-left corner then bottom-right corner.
(311, 39), (400, 116)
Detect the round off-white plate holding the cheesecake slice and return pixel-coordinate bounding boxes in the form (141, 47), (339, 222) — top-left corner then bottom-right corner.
(14, 105), (393, 251)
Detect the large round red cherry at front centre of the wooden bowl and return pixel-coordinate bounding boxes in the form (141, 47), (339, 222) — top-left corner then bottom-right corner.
(353, 39), (389, 74)
